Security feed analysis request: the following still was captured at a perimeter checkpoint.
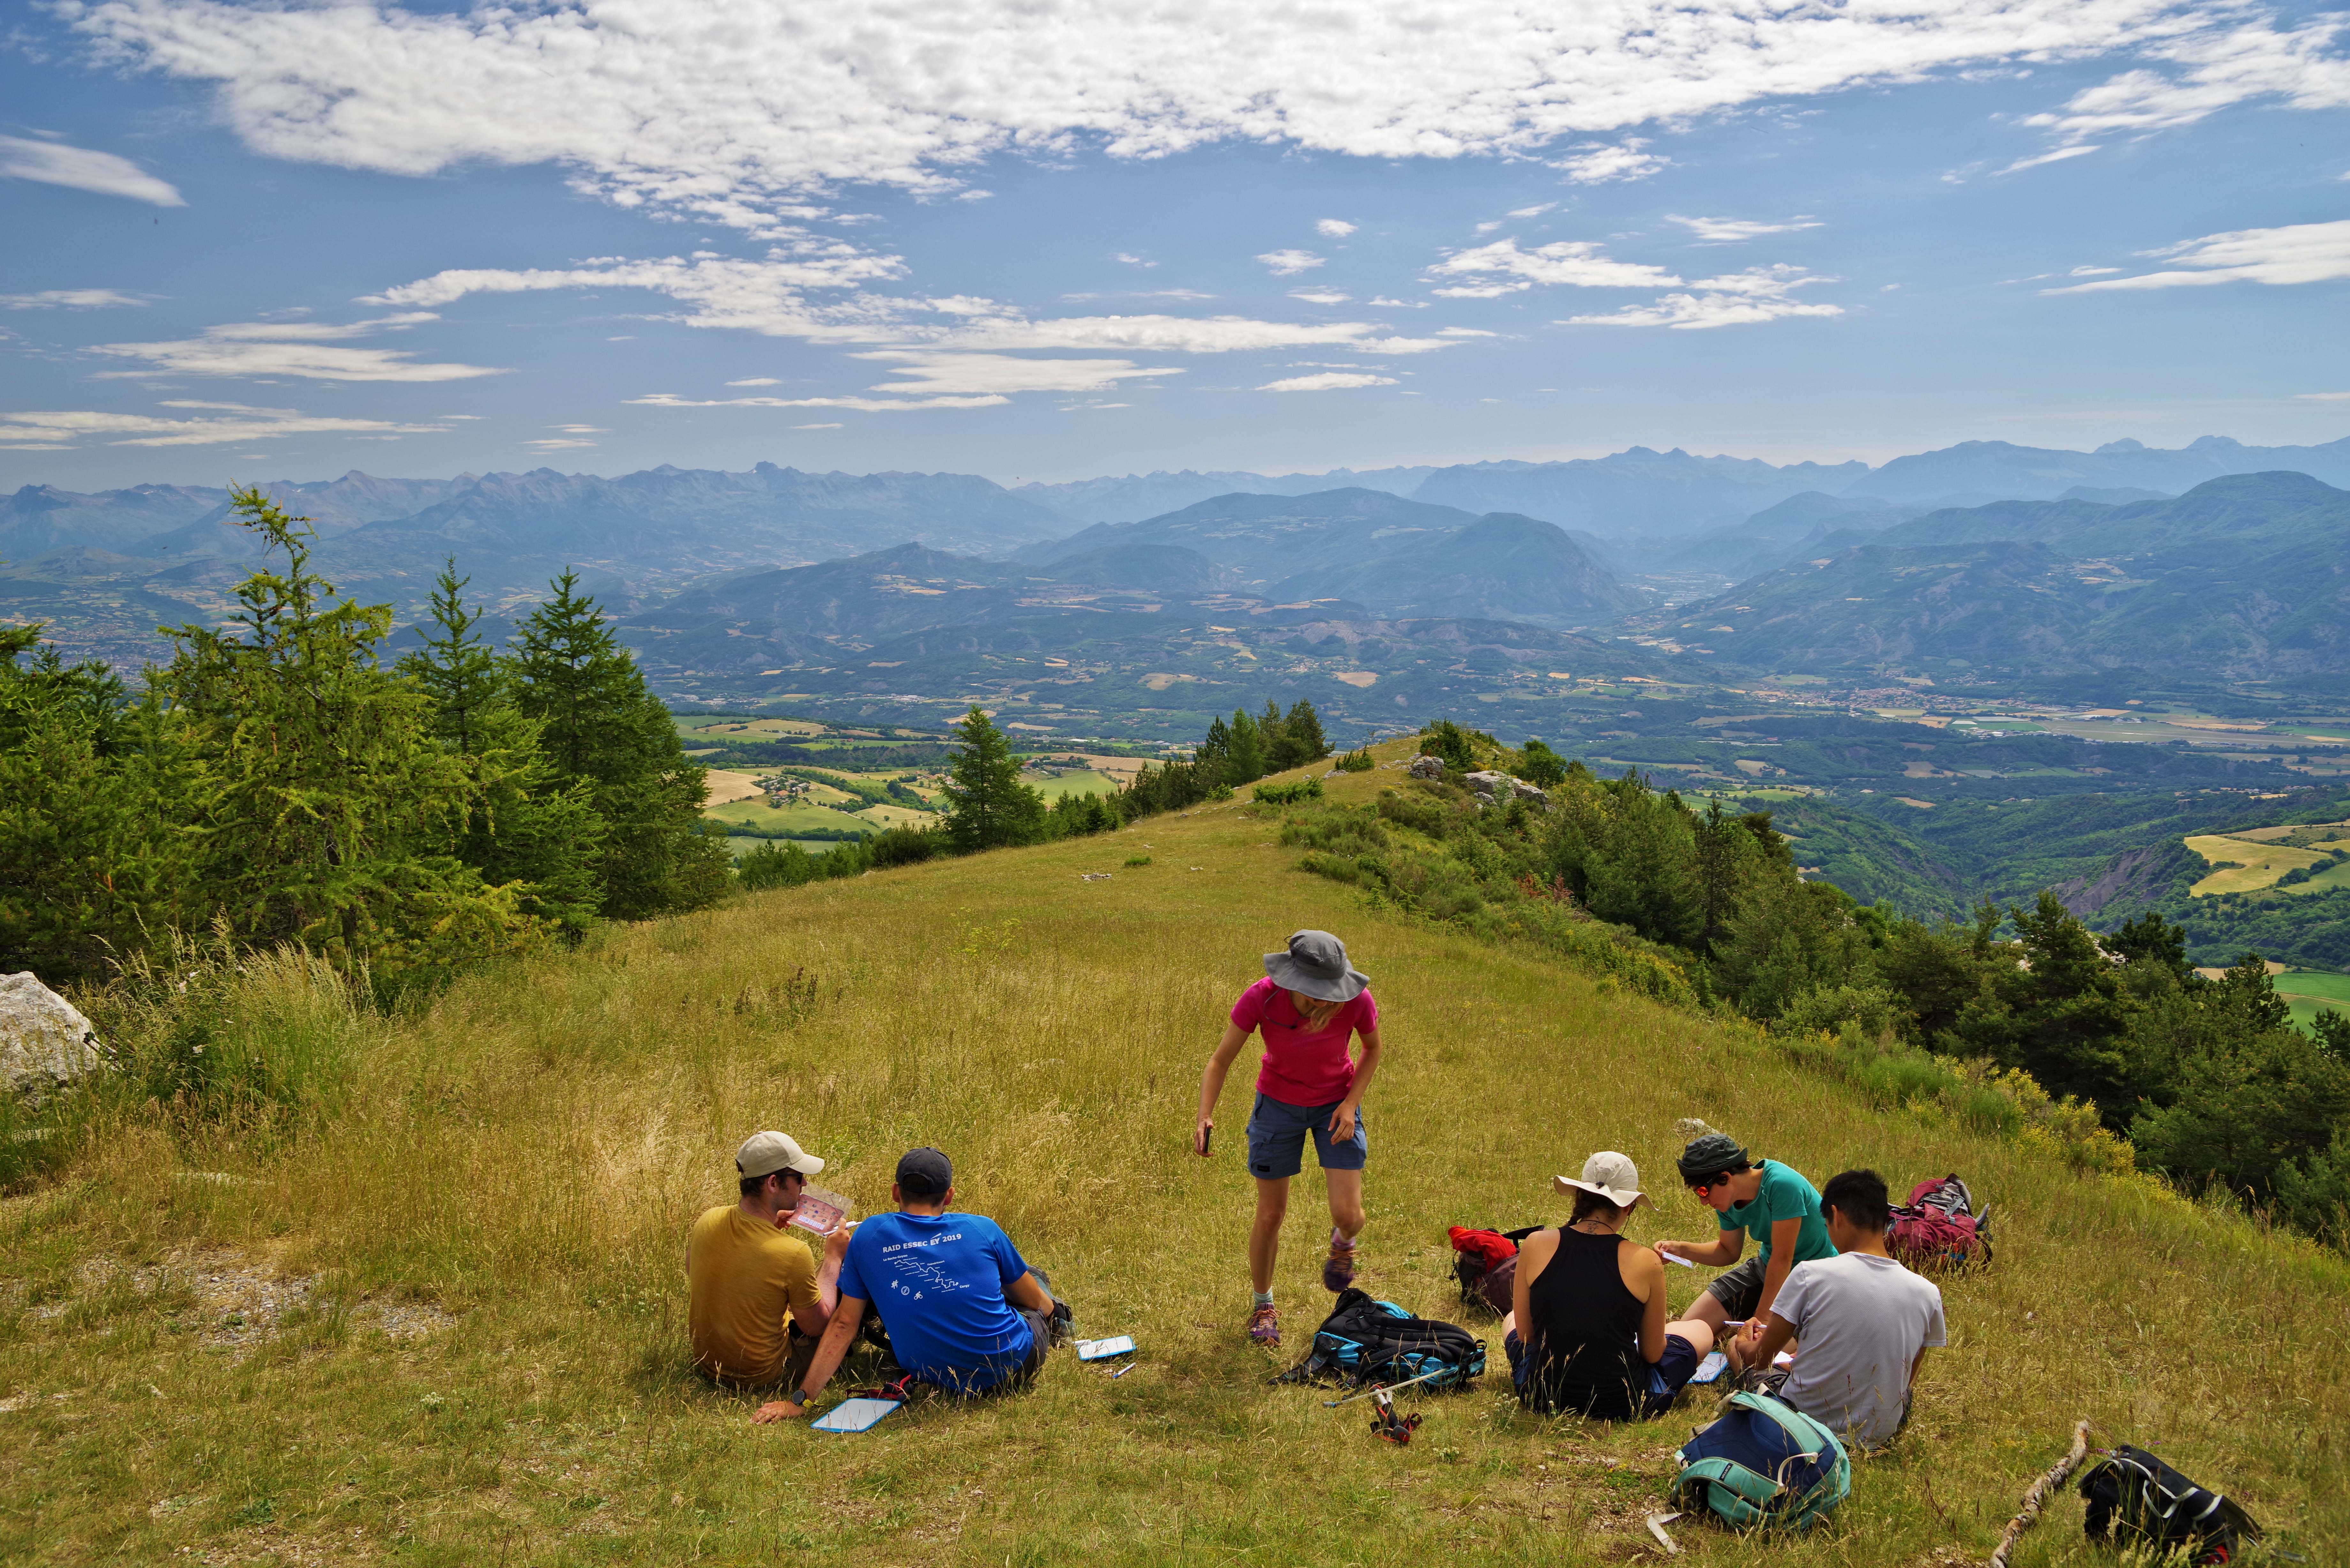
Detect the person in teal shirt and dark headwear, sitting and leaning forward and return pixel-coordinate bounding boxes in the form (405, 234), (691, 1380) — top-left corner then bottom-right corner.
(1657, 1133), (1835, 1340)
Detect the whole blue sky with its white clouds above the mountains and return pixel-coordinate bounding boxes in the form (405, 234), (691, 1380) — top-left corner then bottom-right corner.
(0, 0), (2350, 489)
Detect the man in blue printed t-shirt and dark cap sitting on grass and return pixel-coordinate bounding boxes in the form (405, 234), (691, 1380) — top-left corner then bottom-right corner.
(752, 1150), (1053, 1422)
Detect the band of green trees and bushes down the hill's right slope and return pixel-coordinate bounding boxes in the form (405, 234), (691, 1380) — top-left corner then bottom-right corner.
(1288, 724), (2350, 1244)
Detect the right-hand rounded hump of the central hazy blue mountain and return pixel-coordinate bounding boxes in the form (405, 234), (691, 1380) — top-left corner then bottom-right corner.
(1269, 512), (1645, 625)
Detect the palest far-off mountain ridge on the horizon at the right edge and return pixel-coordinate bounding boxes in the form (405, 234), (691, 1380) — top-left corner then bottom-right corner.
(1840, 435), (2350, 505)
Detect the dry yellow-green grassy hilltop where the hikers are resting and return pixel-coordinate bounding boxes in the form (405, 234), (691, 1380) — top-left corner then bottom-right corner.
(14, 748), (2350, 1566)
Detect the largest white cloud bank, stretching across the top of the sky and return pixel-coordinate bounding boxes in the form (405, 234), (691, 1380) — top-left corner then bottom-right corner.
(83, 0), (2343, 230)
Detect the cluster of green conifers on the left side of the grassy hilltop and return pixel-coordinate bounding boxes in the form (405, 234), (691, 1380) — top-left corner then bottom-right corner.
(0, 489), (729, 983)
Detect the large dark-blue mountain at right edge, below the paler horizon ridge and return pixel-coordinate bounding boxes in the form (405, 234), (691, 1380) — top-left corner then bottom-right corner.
(1671, 472), (2350, 679)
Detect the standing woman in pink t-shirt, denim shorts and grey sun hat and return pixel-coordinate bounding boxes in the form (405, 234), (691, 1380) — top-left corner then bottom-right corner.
(1192, 931), (1379, 1345)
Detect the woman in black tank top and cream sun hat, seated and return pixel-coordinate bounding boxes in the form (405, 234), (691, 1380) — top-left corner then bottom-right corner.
(1502, 1154), (1713, 1420)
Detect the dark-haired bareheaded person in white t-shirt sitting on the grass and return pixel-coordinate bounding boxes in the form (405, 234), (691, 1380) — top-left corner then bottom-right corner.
(1725, 1171), (1951, 1448)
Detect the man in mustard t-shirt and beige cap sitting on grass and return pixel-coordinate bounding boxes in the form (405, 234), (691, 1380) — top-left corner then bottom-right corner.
(686, 1133), (853, 1389)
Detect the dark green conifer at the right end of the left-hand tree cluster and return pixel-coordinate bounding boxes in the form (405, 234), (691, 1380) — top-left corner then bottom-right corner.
(508, 571), (733, 919)
